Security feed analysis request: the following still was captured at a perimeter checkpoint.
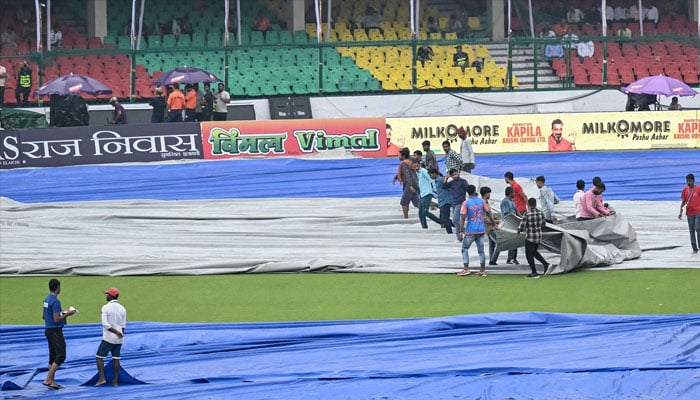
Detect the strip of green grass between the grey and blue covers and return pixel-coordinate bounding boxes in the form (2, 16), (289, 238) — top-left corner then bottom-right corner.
(0, 269), (700, 325)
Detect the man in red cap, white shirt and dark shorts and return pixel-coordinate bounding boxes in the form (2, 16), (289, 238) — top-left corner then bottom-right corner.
(95, 288), (126, 386)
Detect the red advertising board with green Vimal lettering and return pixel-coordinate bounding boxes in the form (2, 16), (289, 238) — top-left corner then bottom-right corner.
(201, 118), (387, 159)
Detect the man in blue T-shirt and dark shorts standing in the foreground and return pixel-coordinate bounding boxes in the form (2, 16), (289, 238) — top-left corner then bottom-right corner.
(42, 279), (77, 389)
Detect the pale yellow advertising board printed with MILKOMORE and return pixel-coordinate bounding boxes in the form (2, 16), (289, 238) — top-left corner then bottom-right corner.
(386, 110), (700, 155)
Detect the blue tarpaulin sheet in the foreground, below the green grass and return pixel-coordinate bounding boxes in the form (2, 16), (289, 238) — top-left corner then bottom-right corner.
(0, 313), (700, 400)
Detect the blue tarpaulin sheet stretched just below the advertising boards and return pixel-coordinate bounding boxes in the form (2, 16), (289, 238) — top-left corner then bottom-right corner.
(0, 150), (700, 203)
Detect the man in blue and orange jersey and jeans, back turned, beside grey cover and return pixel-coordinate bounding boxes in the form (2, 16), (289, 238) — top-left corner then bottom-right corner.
(457, 185), (488, 276)
